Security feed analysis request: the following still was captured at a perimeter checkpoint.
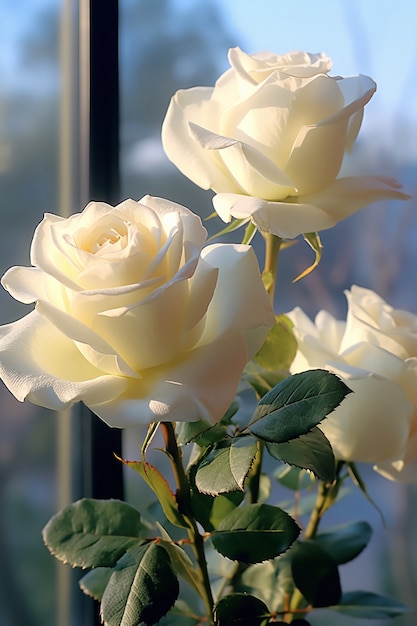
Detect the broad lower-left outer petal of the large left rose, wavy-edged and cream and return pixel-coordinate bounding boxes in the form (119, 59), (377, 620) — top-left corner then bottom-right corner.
(0, 311), (127, 410)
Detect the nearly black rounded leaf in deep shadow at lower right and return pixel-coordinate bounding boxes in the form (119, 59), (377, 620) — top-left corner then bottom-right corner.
(291, 541), (342, 608)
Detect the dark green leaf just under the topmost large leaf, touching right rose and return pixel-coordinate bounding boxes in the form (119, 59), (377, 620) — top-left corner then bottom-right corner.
(266, 426), (336, 483)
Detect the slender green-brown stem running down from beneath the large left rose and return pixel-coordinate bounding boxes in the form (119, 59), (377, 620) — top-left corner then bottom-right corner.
(161, 422), (214, 626)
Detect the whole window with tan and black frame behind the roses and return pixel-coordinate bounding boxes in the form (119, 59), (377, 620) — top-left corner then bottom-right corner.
(0, 0), (417, 626)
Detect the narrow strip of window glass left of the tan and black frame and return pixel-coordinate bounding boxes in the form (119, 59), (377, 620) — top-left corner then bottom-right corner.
(0, 0), (60, 626)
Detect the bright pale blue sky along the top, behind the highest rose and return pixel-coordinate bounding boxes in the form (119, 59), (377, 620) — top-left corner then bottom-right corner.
(0, 0), (417, 159)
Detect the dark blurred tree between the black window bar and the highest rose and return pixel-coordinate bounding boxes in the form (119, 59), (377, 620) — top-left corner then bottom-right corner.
(120, 0), (235, 216)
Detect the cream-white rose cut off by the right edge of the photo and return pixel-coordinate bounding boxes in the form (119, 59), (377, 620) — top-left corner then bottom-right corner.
(288, 286), (417, 482)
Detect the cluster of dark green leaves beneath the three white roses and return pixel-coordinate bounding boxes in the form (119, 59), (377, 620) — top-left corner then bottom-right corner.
(39, 370), (405, 626)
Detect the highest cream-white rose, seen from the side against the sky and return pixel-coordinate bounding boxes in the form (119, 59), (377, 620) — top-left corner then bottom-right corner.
(162, 48), (408, 238)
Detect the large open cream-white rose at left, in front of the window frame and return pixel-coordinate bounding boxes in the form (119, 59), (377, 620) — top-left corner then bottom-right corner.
(0, 196), (274, 427)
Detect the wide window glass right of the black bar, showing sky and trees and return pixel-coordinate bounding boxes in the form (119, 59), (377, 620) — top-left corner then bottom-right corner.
(121, 0), (417, 626)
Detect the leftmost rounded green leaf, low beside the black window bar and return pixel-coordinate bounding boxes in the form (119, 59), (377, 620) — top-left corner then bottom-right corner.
(43, 498), (143, 567)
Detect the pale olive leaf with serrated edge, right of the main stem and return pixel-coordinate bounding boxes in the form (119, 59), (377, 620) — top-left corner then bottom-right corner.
(195, 437), (258, 496)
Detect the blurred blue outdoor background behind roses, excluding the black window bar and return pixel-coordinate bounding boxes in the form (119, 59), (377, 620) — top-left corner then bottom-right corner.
(0, 0), (417, 626)
